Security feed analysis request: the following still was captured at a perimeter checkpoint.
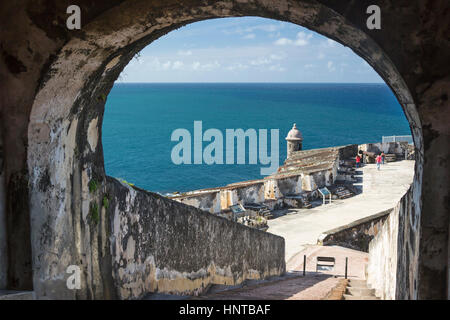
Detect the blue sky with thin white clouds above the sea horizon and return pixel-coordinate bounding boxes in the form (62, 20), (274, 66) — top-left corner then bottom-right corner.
(118, 17), (384, 83)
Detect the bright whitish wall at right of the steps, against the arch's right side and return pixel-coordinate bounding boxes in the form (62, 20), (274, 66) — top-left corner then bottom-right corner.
(367, 180), (420, 300)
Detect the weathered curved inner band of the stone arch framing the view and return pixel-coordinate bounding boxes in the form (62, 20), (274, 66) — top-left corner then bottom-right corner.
(23, 1), (423, 297)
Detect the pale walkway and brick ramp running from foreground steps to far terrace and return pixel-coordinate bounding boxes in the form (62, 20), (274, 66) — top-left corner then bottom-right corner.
(167, 161), (414, 300)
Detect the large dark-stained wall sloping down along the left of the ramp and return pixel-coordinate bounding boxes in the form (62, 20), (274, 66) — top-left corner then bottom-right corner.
(106, 177), (285, 299)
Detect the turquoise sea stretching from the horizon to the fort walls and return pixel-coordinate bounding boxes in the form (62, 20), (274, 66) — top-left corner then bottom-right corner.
(102, 83), (411, 194)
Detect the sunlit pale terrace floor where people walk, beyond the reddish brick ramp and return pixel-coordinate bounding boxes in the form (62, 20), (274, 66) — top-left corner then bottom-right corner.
(267, 160), (414, 262)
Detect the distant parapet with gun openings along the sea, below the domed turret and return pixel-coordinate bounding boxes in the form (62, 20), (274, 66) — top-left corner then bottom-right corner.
(169, 145), (358, 214)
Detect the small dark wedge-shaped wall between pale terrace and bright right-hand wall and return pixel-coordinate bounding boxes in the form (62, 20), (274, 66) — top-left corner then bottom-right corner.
(317, 209), (393, 252)
